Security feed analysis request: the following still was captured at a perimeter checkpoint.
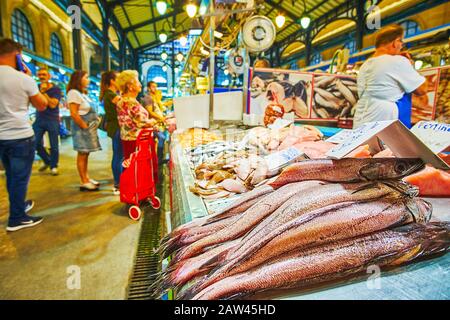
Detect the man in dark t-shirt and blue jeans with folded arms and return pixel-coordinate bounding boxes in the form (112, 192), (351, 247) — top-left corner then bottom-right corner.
(33, 68), (62, 176)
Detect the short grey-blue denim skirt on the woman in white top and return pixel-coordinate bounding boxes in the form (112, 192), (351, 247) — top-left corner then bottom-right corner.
(72, 111), (102, 153)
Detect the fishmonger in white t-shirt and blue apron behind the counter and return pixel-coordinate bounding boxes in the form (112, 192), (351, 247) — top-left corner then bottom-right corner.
(353, 25), (427, 128)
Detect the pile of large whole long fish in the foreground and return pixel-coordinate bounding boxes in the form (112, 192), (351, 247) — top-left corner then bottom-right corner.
(151, 158), (442, 299)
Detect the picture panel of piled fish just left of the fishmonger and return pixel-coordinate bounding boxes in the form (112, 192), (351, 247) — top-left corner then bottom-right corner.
(313, 76), (358, 119)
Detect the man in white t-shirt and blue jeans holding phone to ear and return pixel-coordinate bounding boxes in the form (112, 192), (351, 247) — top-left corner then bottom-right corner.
(0, 39), (48, 231)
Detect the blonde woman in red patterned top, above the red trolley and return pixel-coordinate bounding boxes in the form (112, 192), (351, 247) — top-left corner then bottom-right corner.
(117, 70), (156, 159)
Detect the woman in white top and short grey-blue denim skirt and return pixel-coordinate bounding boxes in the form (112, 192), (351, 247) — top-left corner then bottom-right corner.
(67, 70), (102, 191)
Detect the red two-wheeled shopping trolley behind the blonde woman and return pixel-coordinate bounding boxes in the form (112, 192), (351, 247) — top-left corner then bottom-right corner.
(120, 129), (161, 220)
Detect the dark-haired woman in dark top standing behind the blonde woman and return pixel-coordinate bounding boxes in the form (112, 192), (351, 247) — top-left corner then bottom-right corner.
(100, 71), (123, 195)
